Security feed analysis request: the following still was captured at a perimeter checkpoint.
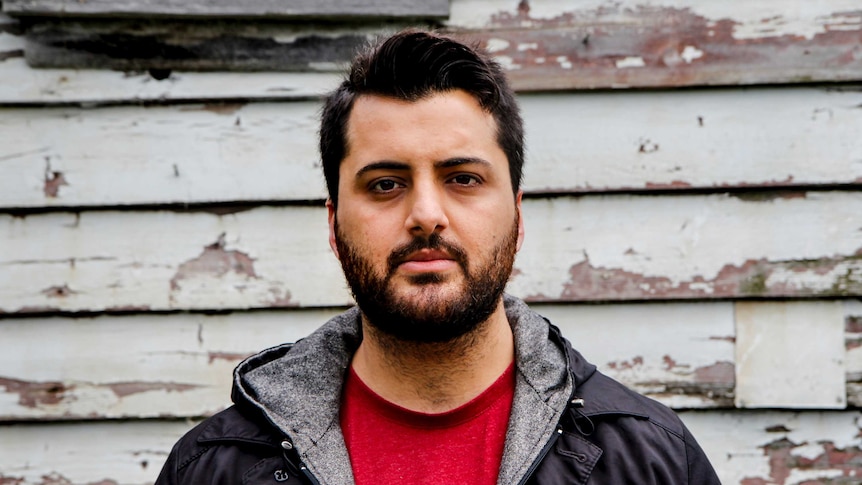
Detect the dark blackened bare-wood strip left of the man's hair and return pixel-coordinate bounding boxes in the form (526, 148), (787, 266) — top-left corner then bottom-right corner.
(24, 21), (381, 71)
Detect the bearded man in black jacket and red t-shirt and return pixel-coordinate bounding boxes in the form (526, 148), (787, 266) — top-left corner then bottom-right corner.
(157, 31), (719, 485)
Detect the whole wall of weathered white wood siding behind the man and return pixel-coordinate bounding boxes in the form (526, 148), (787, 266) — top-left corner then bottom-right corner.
(0, 0), (862, 485)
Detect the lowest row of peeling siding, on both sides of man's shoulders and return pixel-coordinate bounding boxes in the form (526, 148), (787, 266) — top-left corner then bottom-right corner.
(0, 411), (862, 485)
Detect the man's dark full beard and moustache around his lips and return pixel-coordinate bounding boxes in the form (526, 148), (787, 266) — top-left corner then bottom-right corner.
(335, 213), (518, 343)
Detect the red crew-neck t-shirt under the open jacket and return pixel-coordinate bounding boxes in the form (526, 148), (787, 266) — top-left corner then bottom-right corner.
(341, 364), (515, 485)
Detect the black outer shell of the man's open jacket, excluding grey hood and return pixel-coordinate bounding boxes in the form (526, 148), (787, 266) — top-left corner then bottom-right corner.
(156, 300), (720, 485)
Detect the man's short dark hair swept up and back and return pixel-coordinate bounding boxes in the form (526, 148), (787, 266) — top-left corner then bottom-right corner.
(320, 30), (524, 204)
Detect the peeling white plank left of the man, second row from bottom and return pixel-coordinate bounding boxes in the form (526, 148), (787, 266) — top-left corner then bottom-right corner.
(0, 310), (337, 421)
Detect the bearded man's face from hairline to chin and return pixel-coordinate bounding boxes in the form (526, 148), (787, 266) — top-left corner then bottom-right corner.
(327, 90), (523, 342)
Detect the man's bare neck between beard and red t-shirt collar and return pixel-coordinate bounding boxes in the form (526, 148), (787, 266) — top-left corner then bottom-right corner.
(351, 300), (514, 413)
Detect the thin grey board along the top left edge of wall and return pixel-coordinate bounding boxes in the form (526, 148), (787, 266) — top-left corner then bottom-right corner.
(3, 0), (449, 19)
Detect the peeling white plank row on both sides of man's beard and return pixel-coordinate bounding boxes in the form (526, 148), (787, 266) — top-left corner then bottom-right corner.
(0, 191), (862, 313)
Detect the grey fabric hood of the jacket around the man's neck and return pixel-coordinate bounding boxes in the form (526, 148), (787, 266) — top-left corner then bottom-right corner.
(233, 295), (576, 485)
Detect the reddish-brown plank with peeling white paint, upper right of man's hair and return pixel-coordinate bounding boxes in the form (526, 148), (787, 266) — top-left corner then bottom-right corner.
(449, 0), (862, 90)
